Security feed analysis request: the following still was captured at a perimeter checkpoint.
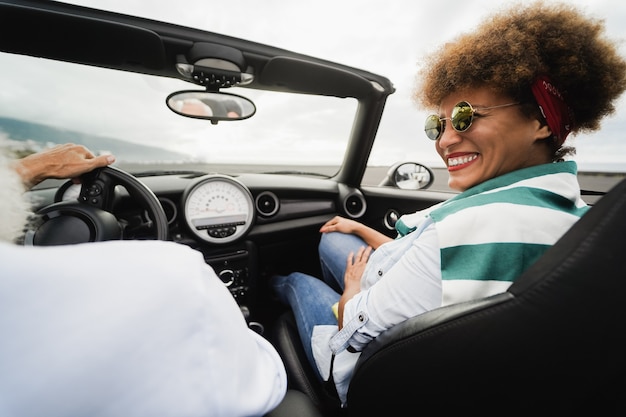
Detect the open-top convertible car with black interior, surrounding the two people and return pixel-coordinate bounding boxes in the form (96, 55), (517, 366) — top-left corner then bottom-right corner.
(0, 0), (626, 416)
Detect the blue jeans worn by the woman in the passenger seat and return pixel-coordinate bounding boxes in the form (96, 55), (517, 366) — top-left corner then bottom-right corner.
(271, 233), (366, 380)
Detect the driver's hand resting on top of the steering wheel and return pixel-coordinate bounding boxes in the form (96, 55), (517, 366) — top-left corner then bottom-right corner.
(12, 143), (115, 188)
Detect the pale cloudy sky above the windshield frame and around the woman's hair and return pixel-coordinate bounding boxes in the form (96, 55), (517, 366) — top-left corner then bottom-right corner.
(19, 0), (626, 168)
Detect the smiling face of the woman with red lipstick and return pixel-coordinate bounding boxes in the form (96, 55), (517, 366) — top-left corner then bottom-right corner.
(435, 88), (551, 191)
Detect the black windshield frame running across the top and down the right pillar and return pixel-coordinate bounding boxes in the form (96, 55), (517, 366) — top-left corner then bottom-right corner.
(0, 0), (395, 186)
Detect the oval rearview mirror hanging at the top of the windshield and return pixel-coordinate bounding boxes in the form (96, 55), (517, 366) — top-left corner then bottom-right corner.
(166, 91), (256, 124)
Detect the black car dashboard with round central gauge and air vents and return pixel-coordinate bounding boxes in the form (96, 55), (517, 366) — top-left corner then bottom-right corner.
(30, 172), (366, 316)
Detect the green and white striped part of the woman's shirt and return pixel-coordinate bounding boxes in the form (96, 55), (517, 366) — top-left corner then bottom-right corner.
(397, 161), (589, 305)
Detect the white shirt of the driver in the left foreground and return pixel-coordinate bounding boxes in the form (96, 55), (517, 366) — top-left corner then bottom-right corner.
(0, 241), (286, 417)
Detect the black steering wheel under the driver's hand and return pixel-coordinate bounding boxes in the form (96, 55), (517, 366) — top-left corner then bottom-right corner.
(25, 167), (168, 246)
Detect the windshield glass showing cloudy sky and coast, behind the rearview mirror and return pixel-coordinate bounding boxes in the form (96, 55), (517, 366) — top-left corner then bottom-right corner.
(0, 54), (357, 173)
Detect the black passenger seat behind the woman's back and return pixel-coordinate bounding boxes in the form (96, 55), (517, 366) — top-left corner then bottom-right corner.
(275, 176), (626, 416)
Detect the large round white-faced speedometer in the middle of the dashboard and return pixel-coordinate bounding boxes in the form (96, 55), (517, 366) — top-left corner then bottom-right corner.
(183, 175), (254, 243)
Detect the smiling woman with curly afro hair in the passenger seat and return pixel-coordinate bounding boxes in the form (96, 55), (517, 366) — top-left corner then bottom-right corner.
(273, 2), (626, 406)
